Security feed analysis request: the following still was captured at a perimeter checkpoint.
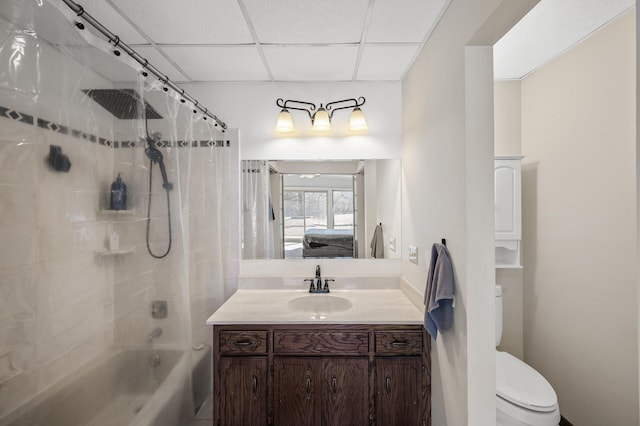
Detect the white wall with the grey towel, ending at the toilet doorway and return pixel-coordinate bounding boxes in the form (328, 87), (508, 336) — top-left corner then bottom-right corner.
(402, 0), (535, 425)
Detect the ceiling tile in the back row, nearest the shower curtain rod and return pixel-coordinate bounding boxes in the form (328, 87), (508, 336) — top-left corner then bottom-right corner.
(161, 46), (269, 81)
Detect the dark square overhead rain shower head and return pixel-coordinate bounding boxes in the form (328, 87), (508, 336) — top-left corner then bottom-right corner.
(82, 89), (162, 120)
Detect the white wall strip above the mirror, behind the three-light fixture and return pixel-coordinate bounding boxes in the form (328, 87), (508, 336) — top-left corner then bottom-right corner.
(183, 82), (402, 160)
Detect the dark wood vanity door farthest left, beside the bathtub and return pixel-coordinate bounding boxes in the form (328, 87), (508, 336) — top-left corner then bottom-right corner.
(220, 357), (267, 426)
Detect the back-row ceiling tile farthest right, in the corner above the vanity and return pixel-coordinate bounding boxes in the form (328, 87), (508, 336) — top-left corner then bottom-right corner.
(358, 44), (420, 81)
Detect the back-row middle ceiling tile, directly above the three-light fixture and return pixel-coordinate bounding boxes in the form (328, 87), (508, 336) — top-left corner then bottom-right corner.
(263, 45), (358, 81)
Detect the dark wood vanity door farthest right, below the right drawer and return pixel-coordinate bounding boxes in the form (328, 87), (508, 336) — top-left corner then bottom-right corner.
(376, 357), (429, 426)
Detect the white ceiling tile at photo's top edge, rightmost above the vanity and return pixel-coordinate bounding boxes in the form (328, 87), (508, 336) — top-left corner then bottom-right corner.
(366, 0), (449, 43)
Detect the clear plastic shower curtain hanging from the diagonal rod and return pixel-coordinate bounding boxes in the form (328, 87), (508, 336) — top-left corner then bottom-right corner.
(0, 0), (240, 424)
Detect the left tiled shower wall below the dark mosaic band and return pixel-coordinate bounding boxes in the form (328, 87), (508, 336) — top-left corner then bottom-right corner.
(0, 118), (114, 416)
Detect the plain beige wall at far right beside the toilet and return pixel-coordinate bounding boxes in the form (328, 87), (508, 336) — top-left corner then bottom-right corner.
(522, 11), (638, 426)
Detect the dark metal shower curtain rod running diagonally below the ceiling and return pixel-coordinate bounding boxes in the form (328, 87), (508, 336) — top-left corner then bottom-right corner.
(63, 0), (227, 132)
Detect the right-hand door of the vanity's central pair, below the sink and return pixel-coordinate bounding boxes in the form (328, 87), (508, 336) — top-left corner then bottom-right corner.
(322, 358), (369, 426)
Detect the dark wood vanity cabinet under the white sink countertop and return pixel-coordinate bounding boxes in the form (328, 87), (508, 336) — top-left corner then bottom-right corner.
(213, 325), (431, 426)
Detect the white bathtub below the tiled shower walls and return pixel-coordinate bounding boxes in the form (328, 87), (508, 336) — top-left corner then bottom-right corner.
(0, 349), (193, 426)
